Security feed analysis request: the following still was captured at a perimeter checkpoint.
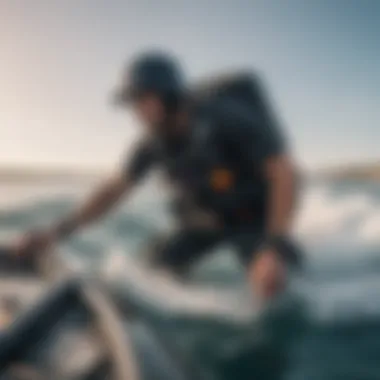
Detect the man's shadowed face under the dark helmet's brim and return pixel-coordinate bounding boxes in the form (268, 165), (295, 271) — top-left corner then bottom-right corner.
(133, 93), (165, 131)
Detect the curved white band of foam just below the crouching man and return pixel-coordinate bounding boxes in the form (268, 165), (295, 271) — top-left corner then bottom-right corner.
(103, 251), (252, 322)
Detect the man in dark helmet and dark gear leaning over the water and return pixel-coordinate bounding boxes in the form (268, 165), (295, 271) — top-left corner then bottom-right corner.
(17, 53), (297, 299)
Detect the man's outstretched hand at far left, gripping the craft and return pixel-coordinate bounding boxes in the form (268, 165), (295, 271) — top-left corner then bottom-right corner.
(13, 231), (55, 257)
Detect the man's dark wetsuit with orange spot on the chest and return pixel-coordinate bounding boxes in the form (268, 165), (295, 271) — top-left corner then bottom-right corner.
(125, 94), (295, 272)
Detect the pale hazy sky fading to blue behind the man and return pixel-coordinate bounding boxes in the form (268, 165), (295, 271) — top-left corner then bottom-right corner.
(0, 0), (380, 167)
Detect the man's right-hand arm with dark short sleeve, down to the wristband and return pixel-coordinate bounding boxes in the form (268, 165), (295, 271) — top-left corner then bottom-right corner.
(221, 101), (297, 238)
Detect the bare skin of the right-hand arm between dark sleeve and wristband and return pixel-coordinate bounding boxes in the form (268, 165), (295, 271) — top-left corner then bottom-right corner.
(267, 158), (296, 236)
